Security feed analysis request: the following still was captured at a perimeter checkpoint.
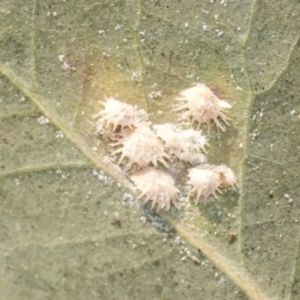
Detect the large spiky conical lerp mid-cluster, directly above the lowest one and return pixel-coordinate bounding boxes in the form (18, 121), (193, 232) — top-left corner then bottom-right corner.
(113, 125), (170, 168)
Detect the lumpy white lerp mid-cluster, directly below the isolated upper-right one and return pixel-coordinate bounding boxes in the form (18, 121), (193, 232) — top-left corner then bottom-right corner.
(153, 123), (207, 163)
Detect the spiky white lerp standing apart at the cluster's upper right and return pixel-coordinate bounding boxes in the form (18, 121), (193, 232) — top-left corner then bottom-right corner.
(176, 84), (231, 131)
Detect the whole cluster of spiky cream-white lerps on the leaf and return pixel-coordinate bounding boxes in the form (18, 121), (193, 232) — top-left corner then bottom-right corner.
(96, 84), (236, 210)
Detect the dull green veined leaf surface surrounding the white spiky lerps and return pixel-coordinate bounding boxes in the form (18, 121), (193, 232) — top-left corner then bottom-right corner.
(0, 0), (300, 299)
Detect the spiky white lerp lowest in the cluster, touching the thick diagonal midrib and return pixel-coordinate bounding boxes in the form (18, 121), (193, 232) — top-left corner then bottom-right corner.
(130, 167), (179, 210)
